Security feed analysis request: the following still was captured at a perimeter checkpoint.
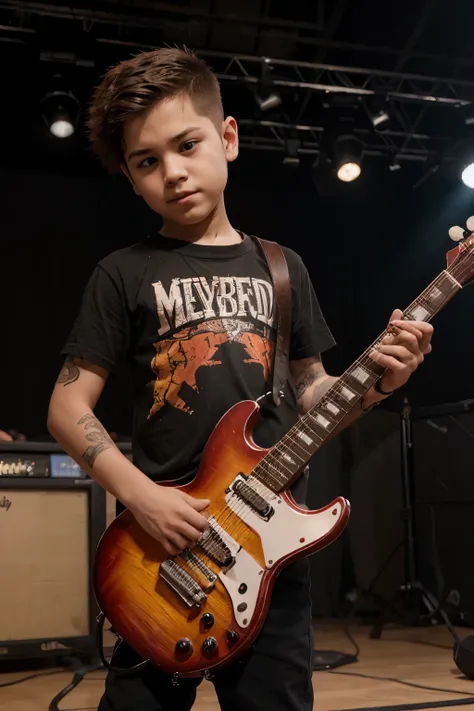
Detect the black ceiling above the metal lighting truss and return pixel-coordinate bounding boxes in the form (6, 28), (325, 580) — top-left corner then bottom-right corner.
(0, 0), (474, 79)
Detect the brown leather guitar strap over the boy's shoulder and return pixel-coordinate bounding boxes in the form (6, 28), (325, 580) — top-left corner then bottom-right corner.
(257, 237), (291, 405)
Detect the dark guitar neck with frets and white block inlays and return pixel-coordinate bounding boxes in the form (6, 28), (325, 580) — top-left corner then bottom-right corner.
(253, 269), (462, 492)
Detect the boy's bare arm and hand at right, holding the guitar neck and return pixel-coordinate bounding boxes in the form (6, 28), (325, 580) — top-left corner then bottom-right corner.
(290, 309), (433, 434)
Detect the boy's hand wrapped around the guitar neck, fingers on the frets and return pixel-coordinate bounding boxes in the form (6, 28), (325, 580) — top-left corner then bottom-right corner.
(370, 309), (433, 392)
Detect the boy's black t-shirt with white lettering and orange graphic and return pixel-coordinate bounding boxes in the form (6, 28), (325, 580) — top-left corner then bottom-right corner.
(63, 235), (334, 500)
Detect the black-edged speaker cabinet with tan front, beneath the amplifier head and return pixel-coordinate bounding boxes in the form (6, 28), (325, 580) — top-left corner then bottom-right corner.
(0, 476), (106, 658)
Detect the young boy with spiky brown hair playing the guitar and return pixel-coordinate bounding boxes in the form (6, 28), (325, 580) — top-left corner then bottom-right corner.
(48, 49), (432, 711)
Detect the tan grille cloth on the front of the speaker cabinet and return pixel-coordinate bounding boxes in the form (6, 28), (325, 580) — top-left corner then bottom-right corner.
(0, 489), (89, 641)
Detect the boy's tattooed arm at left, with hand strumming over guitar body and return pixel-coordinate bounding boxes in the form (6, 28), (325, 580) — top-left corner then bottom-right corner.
(48, 358), (209, 555)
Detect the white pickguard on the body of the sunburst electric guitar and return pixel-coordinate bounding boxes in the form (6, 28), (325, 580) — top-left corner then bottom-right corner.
(219, 483), (342, 628)
